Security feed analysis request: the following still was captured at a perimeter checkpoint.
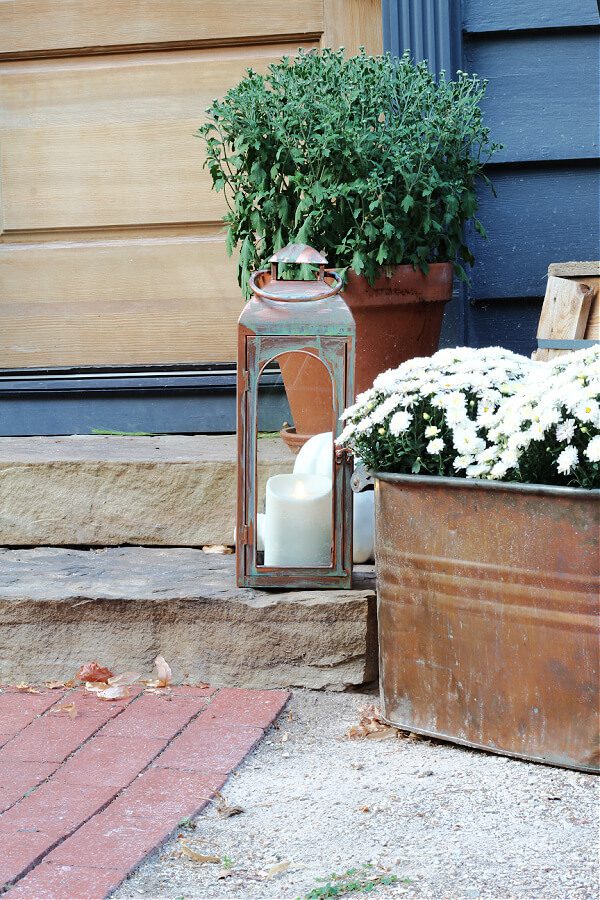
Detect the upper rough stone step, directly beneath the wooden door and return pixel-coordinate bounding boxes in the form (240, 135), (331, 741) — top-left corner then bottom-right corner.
(0, 435), (293, 547)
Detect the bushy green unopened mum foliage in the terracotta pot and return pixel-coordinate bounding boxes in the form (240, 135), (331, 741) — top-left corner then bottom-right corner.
(198, 49), (499, 294)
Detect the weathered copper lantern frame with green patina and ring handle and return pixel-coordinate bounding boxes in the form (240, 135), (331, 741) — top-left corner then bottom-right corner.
(237, 244), (355, 588)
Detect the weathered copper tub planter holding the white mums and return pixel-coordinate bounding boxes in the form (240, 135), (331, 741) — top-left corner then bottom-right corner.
(375, 473), (600, 772)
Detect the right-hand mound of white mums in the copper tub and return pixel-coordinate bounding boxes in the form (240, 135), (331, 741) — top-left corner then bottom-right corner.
(480, 346), (600, 486)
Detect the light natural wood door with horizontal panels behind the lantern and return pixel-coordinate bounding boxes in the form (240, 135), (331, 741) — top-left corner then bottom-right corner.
(0, 0), (381, 369)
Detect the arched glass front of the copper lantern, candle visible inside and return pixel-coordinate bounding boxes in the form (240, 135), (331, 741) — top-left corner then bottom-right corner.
(254, 349), (337, 570)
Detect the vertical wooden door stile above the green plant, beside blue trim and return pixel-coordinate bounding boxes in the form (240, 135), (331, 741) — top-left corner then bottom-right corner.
(321, 0), (383, 56)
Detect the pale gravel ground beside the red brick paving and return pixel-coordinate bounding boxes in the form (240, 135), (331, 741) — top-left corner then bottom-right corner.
(113, 691), (600, 900)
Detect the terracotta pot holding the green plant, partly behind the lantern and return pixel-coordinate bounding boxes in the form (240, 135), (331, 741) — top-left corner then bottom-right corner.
(279, 263), (453, 452)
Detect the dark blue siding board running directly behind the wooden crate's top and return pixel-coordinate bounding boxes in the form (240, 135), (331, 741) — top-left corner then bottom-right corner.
(469, 166), (600, 300)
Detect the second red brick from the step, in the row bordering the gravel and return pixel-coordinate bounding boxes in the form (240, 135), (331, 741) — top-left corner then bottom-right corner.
(154, 716), (264, 774)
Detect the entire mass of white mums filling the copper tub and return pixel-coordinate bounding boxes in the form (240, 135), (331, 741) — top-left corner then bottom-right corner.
(339, 347), (600, 488)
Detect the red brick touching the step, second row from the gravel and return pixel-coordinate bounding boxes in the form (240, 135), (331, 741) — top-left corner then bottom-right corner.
(102, 691), (209, 741)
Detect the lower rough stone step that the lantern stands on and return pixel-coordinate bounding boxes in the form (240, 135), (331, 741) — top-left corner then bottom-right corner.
(0, 547), (377, 690)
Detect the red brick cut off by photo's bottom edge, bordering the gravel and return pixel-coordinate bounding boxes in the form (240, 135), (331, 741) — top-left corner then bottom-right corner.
(3, 862), (125, 900)
